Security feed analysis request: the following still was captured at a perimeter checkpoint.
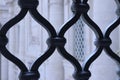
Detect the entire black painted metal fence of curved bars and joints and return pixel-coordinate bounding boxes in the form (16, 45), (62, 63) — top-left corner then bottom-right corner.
(0, 0), (120, 80)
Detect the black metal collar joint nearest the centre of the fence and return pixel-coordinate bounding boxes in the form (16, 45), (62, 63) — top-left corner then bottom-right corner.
(47, 37), (66, 46)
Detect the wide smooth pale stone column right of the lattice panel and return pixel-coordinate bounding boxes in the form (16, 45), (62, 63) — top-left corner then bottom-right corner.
(91, 0), (118, 80)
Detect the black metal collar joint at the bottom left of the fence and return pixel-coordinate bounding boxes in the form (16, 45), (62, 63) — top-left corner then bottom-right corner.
(19, 71), (40, 80)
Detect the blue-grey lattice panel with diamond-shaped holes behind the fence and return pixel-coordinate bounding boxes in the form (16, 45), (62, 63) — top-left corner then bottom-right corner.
(74, 19), (85, 62)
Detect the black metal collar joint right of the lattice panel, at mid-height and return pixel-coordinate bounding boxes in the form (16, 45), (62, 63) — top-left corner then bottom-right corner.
(94, 38), (112, 47)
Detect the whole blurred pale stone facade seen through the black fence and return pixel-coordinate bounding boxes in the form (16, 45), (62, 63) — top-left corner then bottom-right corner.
(0, 0), (120, 80)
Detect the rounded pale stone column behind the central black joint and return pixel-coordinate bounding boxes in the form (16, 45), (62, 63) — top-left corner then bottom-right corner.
(46, 0), (64, 80)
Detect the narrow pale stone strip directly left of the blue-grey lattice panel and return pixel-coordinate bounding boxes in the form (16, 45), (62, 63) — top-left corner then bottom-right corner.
(63, 0), (75, 80)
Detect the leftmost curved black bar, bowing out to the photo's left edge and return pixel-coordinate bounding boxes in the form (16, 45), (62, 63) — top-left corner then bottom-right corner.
(0, 9), (28, 71)
